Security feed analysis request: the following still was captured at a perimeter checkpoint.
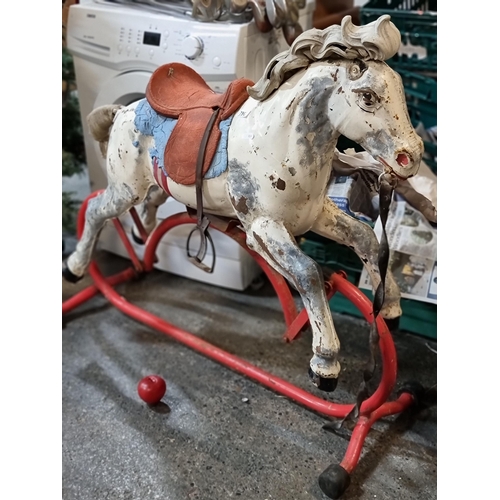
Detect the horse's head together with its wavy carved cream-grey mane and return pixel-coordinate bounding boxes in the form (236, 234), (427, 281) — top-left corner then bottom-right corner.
(249, 15), (423, 179)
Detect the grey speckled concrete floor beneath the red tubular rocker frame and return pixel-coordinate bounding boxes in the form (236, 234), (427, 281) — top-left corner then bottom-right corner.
(62, 247), (437, 500)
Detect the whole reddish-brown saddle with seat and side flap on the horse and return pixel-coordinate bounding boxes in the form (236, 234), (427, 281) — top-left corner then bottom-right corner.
(146, 63), (253, 185)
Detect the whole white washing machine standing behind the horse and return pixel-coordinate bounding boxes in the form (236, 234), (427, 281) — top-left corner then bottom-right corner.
(67, 0), (315, 290)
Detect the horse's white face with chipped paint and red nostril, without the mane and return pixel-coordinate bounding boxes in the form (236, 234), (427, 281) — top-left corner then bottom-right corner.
(330, 60), (424, 179)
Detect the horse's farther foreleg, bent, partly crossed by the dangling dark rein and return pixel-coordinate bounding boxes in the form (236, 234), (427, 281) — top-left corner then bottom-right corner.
(312, 198), (402, 319)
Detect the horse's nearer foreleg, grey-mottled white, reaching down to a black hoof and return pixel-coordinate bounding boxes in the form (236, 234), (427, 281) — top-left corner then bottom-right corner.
(245, 217), (340, 391)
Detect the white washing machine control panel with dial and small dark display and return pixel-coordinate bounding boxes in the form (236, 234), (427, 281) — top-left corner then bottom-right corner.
(68, 4), (274, 81)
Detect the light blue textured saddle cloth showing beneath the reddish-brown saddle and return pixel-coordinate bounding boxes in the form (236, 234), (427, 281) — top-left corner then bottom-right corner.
(134, 99), (234, 179)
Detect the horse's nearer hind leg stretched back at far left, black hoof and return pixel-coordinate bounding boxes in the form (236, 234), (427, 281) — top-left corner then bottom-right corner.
(63, 183), (146, 283)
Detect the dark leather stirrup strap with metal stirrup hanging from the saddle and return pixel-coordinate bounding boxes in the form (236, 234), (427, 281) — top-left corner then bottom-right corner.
(186, 107), (220, 273)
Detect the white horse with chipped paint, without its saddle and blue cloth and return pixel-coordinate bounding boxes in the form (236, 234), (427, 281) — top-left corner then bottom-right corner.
(61, 16), (423, 390)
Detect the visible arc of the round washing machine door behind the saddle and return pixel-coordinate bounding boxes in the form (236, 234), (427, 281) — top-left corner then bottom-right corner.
(94, 71), (149, 108)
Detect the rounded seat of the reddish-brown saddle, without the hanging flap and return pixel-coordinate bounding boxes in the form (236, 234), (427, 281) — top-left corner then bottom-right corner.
(146, 63), (224, 118)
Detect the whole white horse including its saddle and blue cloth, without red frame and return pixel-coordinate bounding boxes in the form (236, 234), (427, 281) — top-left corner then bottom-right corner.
(63, 15), (430, 498)
